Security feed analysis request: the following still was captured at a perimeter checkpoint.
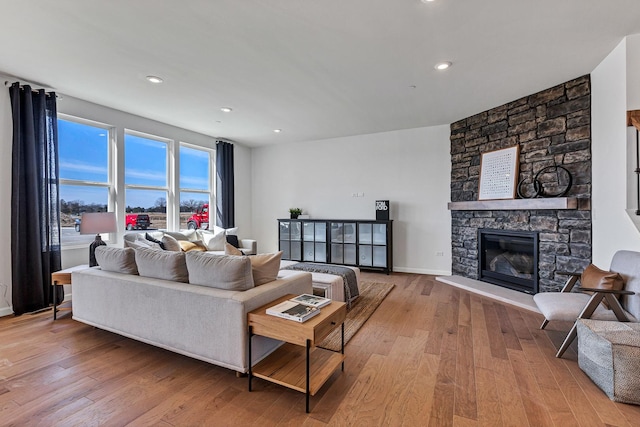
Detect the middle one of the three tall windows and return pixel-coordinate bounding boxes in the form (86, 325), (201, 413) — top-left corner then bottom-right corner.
(124, 132), (169, 230)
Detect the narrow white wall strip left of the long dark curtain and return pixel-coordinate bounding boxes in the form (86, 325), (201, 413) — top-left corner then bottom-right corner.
(0, 87), (13, 316)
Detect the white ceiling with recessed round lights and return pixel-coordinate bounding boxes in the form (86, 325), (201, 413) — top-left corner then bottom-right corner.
(0, 0), (640, 146)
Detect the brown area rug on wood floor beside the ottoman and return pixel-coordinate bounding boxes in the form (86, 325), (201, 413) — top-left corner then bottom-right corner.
(318, 281), (395, 351)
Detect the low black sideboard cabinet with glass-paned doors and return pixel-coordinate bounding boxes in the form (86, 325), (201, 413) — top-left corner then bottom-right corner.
(278, 219), (393, 274)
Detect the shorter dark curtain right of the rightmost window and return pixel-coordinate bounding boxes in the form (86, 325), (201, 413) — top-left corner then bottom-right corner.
(216, 141), (235, 228)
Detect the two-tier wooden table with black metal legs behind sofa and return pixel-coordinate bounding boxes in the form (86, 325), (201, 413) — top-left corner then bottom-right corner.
(248, 295), (347, 413)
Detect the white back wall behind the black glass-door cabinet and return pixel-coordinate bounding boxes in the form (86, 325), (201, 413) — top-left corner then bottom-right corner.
(252, 126), (451, 274)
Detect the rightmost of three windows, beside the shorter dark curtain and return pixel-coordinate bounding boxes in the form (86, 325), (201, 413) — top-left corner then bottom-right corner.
(179, 143), (214, 229)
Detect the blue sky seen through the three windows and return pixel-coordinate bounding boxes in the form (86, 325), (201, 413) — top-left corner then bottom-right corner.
(58, 119), (209, 208)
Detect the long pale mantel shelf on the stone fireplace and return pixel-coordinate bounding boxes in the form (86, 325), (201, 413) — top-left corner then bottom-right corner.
(447, 197), (578, 211)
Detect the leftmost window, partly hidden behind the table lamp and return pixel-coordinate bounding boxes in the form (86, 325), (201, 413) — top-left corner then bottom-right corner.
(58, 115), (112, 245)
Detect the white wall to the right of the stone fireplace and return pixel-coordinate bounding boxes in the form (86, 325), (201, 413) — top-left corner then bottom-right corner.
(591, 36), (640, 268)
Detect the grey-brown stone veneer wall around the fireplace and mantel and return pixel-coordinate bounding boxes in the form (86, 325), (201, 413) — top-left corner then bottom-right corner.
(451, 75), (591, 292)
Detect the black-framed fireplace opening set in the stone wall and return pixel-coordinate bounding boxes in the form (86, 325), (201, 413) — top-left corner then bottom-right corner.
(478, 228), (538, 294)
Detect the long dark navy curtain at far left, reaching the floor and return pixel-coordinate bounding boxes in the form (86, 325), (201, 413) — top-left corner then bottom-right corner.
(9, 83), (63, 315)
